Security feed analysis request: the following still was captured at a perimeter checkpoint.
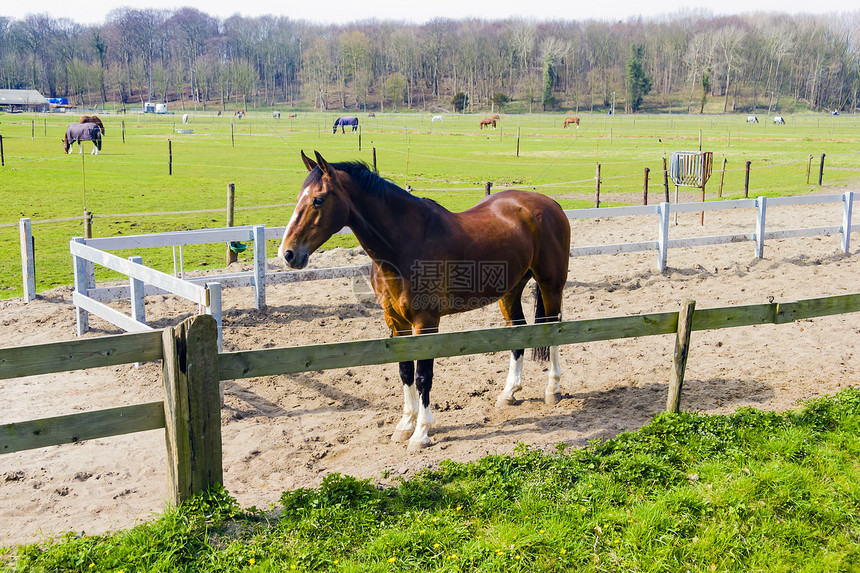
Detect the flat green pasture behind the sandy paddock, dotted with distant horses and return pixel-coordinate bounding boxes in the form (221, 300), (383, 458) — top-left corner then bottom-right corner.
(0, 111), (860, 298)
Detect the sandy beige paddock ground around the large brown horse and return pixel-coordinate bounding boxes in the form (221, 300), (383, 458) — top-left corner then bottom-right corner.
(0, 199), (860, 545)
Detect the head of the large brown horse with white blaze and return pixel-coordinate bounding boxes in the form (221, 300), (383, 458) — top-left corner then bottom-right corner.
(278, 151), (350, 269)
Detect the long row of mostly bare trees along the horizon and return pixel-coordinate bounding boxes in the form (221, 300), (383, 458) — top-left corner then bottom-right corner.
(0, 8), (860, 112)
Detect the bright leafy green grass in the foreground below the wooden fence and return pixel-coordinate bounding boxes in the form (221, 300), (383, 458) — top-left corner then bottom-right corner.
(4, 388), (860, 572)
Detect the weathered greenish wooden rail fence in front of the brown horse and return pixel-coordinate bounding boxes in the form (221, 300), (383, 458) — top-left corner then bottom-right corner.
(0, 293), (860, 504)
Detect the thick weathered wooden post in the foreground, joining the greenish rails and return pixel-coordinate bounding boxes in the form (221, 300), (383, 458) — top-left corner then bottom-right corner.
(162, 315), (223, 505)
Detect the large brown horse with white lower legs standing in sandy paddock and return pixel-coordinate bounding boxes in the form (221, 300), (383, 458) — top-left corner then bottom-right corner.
(278, 151), (570, 450)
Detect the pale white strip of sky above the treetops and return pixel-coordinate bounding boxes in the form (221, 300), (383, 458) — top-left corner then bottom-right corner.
(0, 0), (856, 24)
